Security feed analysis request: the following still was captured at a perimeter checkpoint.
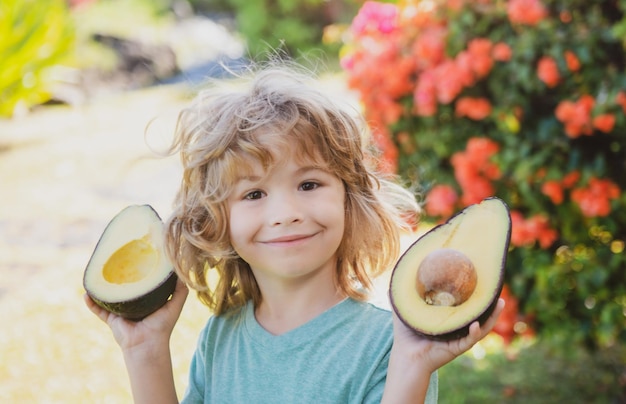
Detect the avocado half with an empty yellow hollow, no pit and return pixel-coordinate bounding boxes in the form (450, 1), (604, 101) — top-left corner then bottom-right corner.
(83, 205), (177, 321)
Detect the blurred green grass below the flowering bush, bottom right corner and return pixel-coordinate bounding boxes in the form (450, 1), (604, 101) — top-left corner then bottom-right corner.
(439, 343), (626, 404)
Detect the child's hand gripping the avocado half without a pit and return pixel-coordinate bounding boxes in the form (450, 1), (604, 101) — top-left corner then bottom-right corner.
(84, 279), (189, 351)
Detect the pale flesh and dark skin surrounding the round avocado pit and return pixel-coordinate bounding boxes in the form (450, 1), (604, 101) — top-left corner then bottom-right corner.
(389, 198), (511, 340)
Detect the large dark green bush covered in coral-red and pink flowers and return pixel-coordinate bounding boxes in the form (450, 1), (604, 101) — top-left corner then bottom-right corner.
(342, 0), (626, 348)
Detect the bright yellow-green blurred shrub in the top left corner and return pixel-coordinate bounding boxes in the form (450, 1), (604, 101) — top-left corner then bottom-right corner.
(0, 0), (74, 117)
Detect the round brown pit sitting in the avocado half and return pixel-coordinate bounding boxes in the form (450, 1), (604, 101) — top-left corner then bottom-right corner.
(416, 248), (477, 306)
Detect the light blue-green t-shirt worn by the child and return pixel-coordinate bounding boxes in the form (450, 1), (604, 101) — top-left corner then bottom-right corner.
(183, 299), (437, 404)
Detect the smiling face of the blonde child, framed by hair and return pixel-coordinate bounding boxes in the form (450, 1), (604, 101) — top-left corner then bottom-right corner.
(228, 153), (345, 284)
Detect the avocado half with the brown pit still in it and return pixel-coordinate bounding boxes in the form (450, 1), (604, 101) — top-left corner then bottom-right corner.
(389, 197), (511, 341)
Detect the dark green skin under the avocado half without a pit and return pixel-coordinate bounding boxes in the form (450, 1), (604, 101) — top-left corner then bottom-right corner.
(89, 272), (178, 321)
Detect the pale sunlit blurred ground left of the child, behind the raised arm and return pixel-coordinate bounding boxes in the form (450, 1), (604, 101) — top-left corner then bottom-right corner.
(0, 86), (200, 403)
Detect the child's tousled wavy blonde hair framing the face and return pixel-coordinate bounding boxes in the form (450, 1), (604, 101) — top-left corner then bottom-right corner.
(166, 63), (419, 315)
